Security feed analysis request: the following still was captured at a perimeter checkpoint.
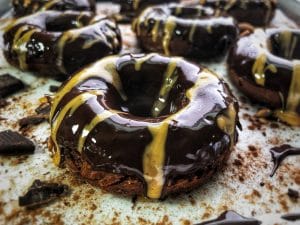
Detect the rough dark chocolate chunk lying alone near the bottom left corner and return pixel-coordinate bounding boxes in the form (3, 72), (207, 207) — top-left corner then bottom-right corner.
(19, 180), (70, 208)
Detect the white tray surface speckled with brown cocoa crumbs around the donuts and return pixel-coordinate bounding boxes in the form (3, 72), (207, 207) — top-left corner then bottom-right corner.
(0, 2), (300, 225)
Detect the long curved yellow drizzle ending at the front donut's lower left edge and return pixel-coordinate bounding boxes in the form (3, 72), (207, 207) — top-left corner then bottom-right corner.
(51, 92), (101, 166)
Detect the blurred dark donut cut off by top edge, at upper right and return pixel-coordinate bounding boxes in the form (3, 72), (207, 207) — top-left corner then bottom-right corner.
(199, 0), (277, 26)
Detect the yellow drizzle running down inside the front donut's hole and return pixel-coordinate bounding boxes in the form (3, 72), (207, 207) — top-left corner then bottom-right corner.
(151, 58), (180, 117)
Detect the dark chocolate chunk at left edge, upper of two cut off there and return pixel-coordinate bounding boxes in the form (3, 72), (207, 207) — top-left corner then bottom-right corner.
(0, 74), (24, 97)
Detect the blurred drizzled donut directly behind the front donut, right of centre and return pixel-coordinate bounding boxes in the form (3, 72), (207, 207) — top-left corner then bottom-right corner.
(133, 4), (238, 59)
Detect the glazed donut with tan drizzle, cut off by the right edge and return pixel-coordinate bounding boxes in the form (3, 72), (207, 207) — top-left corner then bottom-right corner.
(228, 29), (300, 126)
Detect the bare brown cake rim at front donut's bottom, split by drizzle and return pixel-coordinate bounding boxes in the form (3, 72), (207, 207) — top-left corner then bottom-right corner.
(65, 149), (231, 198)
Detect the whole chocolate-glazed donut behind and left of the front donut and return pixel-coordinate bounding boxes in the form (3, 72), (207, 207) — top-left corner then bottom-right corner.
(4, 11), (121, 76)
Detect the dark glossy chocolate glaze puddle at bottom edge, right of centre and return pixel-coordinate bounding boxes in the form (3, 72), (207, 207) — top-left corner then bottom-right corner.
(195, 211), (261, 225)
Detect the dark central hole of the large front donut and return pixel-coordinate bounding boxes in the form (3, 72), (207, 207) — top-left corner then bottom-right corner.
(119, 59), (192, 118)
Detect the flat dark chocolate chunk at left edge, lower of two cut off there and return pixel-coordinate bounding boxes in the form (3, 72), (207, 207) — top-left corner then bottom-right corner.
(0, 130), (35, 155)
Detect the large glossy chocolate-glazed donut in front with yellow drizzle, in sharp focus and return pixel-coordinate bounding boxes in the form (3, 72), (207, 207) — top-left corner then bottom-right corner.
(50, 54), (238, 199)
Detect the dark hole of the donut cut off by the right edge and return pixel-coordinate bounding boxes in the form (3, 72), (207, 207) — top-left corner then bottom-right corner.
(269, 30), (300, 60)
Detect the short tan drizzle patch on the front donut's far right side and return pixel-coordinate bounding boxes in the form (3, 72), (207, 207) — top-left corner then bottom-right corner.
(217, 103), (237, 148)
